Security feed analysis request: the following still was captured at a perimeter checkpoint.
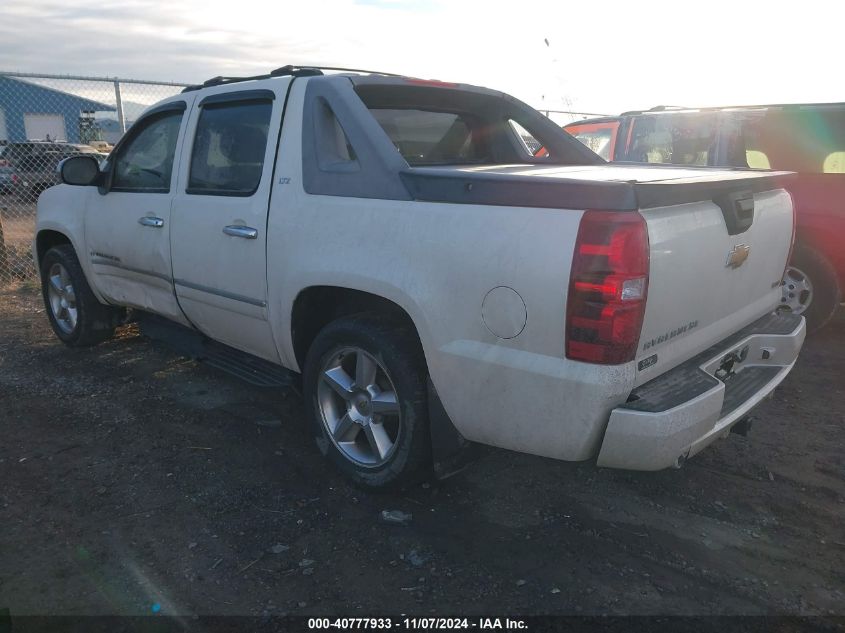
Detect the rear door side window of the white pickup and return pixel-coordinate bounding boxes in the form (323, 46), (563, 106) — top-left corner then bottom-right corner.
(187, 101), (273, 196)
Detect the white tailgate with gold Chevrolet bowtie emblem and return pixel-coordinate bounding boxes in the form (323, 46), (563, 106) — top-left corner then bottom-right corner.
(636, 177), (793, 385)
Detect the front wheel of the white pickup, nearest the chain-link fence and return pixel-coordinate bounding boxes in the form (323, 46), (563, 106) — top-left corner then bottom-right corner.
(41, 244), (120, 347)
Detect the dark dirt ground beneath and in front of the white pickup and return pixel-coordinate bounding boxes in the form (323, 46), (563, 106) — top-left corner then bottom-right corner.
(0, 290), (845, 616)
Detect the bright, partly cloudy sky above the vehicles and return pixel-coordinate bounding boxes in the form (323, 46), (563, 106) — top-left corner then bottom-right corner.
(0, 0), (845, 114)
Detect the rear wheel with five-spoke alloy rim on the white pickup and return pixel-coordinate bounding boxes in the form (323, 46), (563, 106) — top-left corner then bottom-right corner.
(303, 314), (430, 489)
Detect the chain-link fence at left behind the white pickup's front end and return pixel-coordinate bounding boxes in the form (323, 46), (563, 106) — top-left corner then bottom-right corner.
(0, 71), (184, 286)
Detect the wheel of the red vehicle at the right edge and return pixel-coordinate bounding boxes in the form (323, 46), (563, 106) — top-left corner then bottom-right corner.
(781, 246), (842, 332)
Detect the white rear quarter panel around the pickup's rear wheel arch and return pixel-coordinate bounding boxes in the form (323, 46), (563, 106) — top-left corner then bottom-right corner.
(268, 84), (633, 459)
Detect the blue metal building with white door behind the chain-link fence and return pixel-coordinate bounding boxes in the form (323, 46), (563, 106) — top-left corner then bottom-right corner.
(0, 75), (115, 143)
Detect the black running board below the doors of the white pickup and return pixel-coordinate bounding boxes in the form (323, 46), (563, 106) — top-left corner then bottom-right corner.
(138, 313), (298, 387)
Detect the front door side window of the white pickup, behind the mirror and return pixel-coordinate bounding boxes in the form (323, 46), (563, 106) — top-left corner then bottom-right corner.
(112, 110), (182, 193)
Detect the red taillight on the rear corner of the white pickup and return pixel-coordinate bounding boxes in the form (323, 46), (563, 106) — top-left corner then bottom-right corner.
(566, 211), (649, 365)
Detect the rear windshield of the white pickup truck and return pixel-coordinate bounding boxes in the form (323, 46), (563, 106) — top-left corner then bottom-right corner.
(356, 84), (598, 166)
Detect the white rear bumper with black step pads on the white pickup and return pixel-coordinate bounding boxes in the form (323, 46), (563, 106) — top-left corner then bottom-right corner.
(597, 314), (805, 470)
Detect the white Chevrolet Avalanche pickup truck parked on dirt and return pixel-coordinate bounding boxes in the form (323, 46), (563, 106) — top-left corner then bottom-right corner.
(33, 67), (804, 488)
